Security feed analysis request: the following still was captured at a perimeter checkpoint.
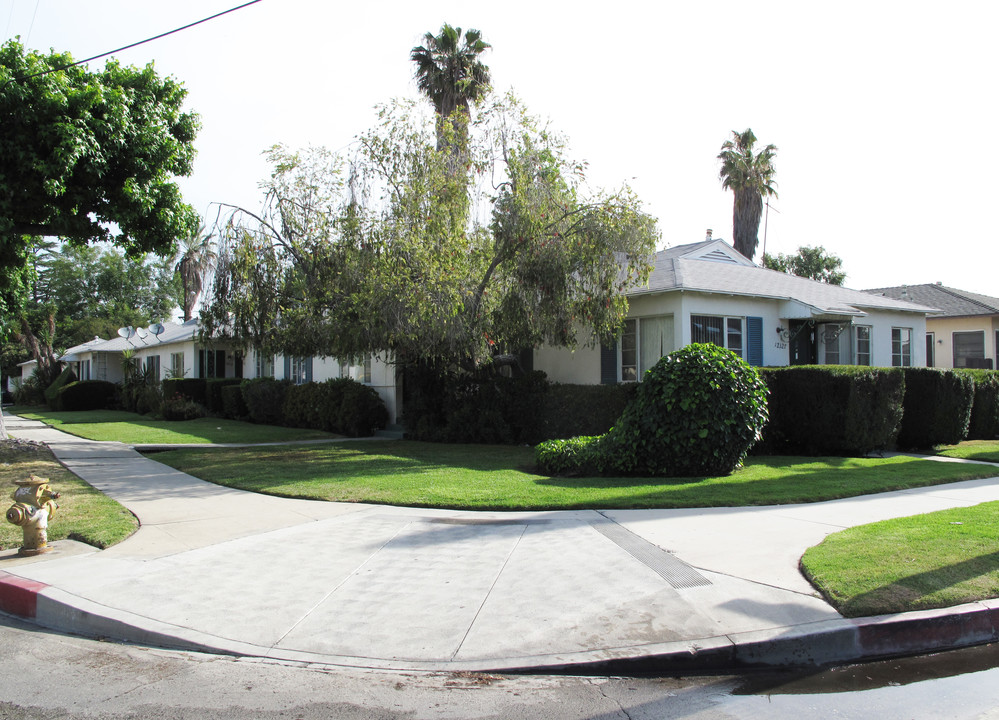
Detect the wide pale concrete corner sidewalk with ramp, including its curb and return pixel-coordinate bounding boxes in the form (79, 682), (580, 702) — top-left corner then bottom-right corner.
(0, 416), (999, 673)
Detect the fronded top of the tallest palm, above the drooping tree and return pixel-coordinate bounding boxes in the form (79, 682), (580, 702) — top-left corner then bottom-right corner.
(409, 23), (491, 150)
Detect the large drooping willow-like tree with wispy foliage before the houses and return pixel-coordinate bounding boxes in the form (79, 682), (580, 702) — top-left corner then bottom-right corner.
(201, 96), (658, 369)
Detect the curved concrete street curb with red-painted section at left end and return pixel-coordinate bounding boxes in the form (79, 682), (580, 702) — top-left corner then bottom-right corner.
(0, 571), (999, 675)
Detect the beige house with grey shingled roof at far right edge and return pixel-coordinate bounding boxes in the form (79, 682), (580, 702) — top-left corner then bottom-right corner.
(866, 283), (999, 369)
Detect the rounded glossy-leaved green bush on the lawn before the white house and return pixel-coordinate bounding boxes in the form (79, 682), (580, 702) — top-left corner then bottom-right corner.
(601, 343), (767, 477)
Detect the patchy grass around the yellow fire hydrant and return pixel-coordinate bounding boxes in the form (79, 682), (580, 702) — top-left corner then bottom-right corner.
(0, 440), (139, 550)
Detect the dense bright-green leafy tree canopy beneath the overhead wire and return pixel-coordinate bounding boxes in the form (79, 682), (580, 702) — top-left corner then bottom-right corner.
(0, 40), (199, 268)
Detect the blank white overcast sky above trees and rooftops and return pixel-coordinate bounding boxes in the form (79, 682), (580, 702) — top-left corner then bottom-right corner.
(0, 0), (999, 296)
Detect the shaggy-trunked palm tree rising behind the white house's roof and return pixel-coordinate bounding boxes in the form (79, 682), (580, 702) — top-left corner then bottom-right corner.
(718, 128), (777, 260)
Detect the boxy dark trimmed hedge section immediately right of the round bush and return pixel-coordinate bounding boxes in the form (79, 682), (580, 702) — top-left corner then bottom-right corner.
(753, 365), (905, 457)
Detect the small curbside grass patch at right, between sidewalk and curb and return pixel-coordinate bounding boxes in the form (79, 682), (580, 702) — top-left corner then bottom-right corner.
(802, 502), (999, 617)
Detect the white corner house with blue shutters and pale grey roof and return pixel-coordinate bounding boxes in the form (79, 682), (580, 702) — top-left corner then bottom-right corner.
(533, 239), (933, 384)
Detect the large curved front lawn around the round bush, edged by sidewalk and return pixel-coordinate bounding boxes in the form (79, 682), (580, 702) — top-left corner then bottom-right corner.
(155, 440), (999, 510)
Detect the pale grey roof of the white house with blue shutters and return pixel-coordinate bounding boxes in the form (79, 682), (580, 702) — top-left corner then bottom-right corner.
(628, 240), (935, 316)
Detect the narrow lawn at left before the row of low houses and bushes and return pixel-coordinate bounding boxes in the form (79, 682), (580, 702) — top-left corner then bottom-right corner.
(17, 408), (338, 445)
